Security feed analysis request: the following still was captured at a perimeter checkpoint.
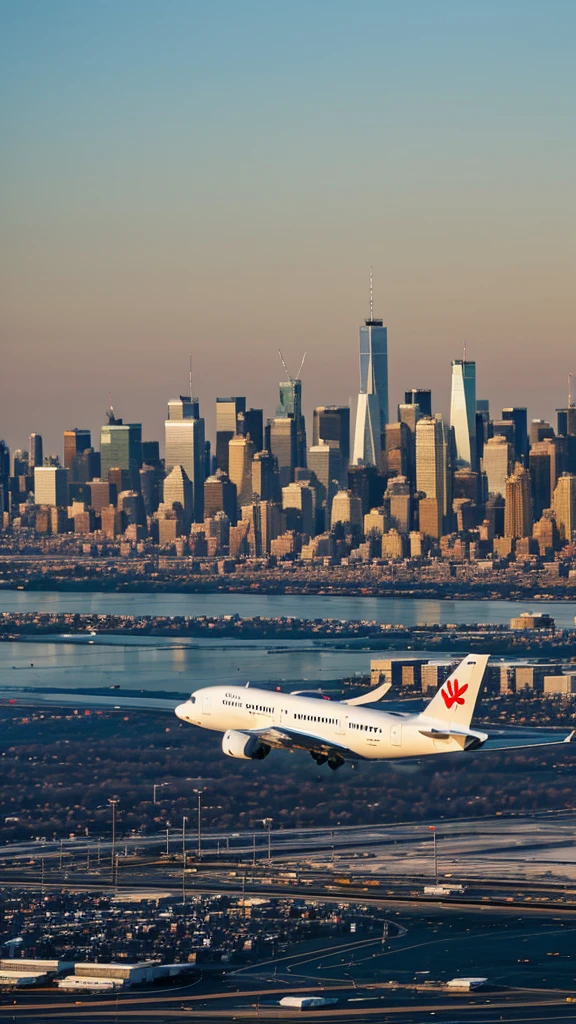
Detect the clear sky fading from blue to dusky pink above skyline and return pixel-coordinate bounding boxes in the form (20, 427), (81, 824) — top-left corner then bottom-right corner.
(0, 0), (576, 451)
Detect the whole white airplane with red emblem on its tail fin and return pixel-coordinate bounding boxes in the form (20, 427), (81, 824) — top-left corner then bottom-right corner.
(175, 654), (573, 770)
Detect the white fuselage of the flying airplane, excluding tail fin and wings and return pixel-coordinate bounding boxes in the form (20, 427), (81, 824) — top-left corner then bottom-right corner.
(176, 686), (486, 760)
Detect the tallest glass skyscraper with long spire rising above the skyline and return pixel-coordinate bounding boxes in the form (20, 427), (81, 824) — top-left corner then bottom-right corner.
(353, 272), (388, 466)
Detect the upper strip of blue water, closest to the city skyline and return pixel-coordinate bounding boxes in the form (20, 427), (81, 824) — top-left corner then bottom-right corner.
(0, 590), (576, 629)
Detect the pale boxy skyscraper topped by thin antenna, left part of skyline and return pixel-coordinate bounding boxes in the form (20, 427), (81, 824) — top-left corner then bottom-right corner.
(164, 395), (205, 522)
